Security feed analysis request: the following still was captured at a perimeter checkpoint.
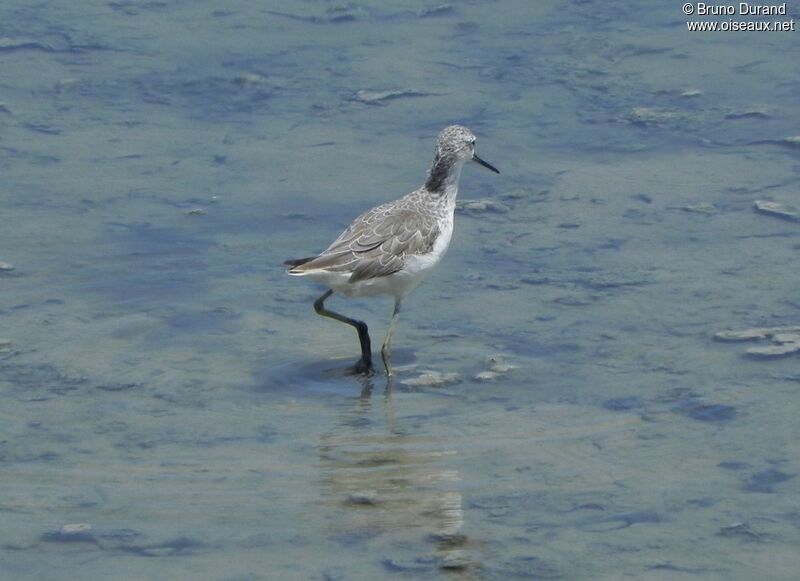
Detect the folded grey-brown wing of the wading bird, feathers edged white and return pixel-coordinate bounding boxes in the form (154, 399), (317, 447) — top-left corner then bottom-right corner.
(296, 202), (439, 282)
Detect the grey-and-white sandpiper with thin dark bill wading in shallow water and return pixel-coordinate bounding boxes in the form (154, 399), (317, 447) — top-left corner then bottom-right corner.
(285, 125), (500, 377)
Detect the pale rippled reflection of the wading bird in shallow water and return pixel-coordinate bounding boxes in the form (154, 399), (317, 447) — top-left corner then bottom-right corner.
(319, 377), (480, 579)
